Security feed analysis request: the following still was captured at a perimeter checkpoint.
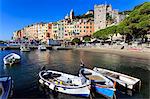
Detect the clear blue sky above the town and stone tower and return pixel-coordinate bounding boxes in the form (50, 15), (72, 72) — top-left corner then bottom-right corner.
(0, 0), (150, 40)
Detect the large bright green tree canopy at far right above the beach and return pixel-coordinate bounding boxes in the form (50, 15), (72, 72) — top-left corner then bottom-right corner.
(118, 2), (150, 40)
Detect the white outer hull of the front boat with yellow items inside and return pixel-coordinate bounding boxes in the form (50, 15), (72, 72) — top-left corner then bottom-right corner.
(39, 72), (90, 97)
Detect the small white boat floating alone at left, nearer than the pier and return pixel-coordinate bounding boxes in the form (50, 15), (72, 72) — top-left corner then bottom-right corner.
(3, 53), (21, 65)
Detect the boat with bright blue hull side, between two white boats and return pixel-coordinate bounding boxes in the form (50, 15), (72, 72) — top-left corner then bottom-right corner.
(79, 68), (115, 98)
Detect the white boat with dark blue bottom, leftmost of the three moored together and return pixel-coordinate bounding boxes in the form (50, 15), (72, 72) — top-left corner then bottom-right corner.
(39, 70), (90, 97)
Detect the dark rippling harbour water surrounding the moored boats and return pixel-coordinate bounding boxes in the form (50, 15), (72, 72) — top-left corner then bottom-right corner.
(0, 50), (150, 99)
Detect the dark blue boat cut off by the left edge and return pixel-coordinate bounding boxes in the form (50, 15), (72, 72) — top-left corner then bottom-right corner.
(0, 76), (13, 99)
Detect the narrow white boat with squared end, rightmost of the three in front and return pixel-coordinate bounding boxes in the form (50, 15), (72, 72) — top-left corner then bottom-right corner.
(93, 67), (141, 90)
